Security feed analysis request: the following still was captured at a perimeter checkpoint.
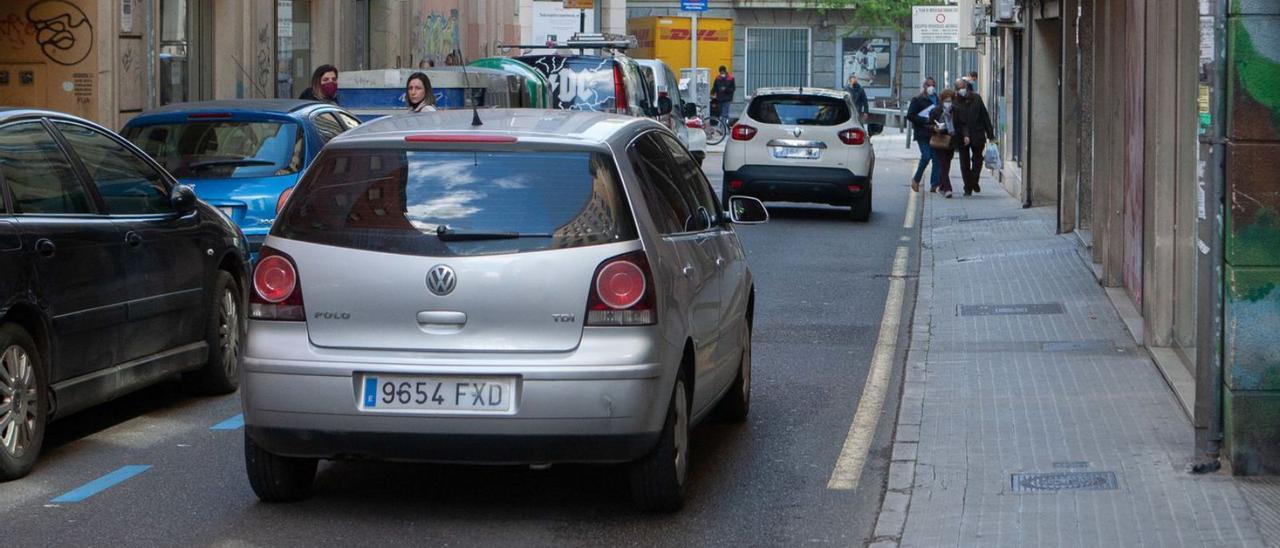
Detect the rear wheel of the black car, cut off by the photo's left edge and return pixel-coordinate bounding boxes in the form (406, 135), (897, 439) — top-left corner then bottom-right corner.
(0, 324), (49, 481)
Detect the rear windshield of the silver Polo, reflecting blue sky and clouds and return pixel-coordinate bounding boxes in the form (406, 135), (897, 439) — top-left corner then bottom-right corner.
(280, 149), (636, 256)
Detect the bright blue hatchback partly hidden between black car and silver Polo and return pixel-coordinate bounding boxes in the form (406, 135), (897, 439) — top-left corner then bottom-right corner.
(120, 99), (360, 259)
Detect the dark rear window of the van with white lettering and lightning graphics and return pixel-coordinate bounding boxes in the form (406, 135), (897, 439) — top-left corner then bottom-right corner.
(520, 55), (617, 111)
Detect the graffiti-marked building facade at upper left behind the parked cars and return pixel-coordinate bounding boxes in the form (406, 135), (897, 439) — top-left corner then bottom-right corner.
(0, 0), (520, 128)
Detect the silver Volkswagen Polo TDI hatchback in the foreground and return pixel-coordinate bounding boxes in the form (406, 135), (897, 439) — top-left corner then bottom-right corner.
(241, 110), (767, 511)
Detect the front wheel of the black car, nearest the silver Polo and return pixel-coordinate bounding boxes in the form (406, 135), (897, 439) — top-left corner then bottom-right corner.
(188, 270), (247, 396)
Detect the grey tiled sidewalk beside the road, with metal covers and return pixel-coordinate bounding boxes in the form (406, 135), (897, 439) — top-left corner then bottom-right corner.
(872, 138), (1280, 547)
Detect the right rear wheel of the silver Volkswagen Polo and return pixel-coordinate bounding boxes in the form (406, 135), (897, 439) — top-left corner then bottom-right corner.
(628, 375), (689, 512)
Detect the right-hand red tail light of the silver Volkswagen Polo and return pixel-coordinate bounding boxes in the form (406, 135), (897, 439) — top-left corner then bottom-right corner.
(586, 251), (657, 325)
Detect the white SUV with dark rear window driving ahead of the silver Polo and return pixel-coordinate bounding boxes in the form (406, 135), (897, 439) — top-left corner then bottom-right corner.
(723, 87), (883, 222)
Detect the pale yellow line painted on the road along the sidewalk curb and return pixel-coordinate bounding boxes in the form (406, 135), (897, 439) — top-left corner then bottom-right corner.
(827, 245), (915, 489)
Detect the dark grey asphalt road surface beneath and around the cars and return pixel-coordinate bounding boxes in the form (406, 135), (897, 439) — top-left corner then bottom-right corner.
(0, 141), (918, 545)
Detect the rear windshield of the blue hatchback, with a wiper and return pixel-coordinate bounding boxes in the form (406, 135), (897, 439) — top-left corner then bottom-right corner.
(124, 120), (303, 179)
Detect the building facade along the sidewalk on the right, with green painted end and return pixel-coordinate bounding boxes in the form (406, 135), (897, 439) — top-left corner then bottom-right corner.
(977, 0), (1280, 474)
